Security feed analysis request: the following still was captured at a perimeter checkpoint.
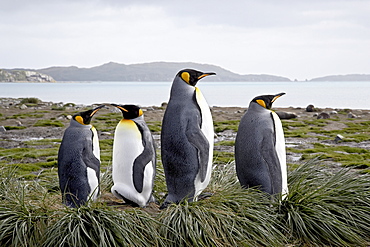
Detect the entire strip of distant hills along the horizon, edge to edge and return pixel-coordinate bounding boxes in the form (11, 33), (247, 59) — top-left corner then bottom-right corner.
(0, 61), (370, 82)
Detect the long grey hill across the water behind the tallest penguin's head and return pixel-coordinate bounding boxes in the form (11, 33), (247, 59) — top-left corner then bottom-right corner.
(35, 62), (290, 82)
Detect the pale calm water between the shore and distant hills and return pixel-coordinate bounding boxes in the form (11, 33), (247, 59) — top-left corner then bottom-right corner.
(0, 80), (370, 109)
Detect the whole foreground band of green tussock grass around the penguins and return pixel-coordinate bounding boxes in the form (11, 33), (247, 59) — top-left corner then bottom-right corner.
(0, 160), (370, 246)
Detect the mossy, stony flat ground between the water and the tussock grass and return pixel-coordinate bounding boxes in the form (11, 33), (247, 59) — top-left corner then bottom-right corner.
(0, 98), (370, 172)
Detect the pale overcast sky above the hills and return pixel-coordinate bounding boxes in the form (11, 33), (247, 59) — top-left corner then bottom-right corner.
(0, 0), (370, 80)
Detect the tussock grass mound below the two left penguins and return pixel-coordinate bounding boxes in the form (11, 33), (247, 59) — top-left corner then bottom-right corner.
(44, 204), (160, 247)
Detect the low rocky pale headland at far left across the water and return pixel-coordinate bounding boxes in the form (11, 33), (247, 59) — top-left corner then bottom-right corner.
(0, 69), (55, 82)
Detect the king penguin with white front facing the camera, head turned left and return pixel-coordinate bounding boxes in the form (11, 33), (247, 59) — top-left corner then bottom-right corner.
(111, 104), (156, 207)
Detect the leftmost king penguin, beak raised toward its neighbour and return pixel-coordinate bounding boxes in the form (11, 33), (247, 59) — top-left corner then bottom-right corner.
(58, 105), (105, 207)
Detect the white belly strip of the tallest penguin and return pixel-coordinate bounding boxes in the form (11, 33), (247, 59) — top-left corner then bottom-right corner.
(194, 88), (215, 200)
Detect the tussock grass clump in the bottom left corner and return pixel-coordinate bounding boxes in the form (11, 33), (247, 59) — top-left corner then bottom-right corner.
(0, 168), (53, 246)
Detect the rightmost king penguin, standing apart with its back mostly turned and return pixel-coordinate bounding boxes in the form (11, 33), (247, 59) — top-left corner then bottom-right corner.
(235, 93), (288, 198)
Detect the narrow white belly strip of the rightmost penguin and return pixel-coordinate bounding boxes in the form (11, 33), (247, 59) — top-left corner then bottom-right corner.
(272, 112), (288, 198)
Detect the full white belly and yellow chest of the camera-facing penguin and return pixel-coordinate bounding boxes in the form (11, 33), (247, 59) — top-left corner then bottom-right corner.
(111, 120), (154, 206)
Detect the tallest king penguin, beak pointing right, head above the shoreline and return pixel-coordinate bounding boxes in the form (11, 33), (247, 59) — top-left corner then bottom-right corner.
(161, 69), (215, 209)
